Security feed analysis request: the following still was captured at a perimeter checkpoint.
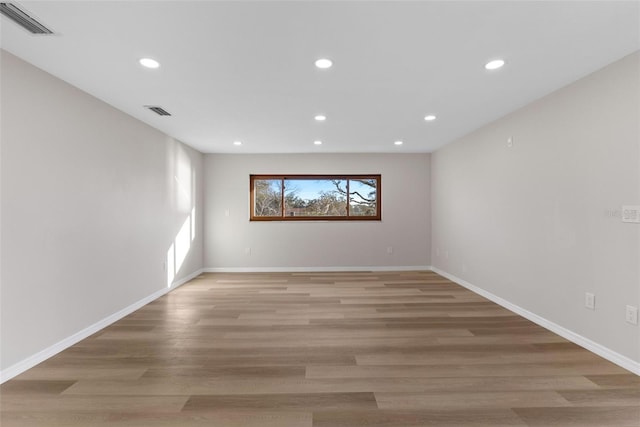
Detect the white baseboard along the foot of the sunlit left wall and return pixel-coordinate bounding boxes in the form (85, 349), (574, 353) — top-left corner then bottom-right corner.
(0, 269), (203, 384)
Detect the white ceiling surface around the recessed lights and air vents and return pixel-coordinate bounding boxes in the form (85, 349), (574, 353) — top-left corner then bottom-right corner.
(1, 1), (640, 153)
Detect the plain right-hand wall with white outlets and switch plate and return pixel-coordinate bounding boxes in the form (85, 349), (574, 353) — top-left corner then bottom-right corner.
(432, 53), (640, 366)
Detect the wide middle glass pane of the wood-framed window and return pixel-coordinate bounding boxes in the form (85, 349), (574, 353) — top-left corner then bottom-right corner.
(284, 179), (347, 216)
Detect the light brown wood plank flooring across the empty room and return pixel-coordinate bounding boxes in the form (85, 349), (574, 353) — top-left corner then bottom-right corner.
(0, 272), (640, 427)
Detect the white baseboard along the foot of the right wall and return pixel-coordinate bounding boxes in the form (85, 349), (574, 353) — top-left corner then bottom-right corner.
(431, 267), (640, 375)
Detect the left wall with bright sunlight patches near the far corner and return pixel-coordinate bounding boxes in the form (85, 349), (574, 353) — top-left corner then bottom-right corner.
(0, 51), (203, 378)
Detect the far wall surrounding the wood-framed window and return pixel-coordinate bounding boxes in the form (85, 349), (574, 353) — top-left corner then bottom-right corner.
(204, 153), (430, 270)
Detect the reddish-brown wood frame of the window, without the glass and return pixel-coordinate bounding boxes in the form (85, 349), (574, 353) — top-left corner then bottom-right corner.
(249, 174), (382, 221)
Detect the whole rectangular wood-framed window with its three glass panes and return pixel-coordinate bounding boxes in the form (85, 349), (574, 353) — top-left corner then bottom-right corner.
(249, 175), (382, 221)
